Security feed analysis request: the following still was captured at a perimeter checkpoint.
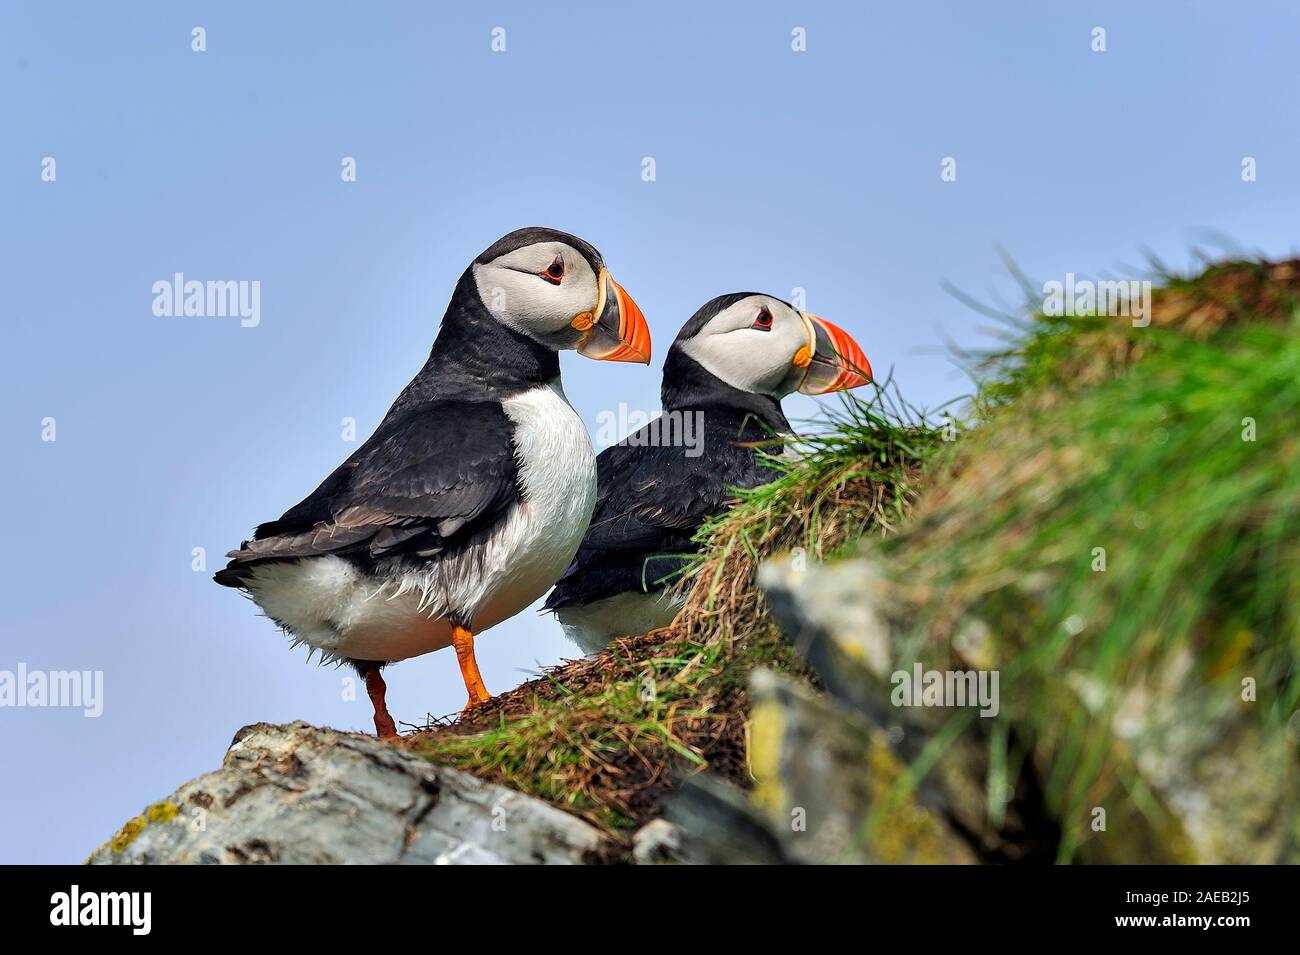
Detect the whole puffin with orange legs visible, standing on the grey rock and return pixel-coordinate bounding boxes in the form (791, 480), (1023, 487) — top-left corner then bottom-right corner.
(215, 227), (660, 737)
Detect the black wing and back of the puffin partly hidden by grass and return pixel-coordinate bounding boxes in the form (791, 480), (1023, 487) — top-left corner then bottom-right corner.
(545, 426), (776, 611)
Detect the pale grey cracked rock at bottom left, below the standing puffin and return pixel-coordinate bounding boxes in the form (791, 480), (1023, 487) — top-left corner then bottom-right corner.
(88, 722), (612, 865)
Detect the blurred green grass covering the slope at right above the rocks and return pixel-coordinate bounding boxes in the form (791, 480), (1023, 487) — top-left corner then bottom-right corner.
(885, 264), (1300, 860)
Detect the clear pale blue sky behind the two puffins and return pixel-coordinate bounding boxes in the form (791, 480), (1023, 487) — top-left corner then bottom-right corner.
(0, 0), (1300, 861)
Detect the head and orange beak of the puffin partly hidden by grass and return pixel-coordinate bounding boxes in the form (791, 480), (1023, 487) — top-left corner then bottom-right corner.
(663, 292), (871, 401)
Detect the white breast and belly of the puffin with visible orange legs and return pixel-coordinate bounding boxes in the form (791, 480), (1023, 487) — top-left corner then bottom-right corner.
(248, 379), (595, 660)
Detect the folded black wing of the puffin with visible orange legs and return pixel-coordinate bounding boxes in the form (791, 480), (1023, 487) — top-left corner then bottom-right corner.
(216, 400), (520, 586)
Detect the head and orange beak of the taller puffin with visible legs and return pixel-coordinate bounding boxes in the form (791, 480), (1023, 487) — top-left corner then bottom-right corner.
(469, 226), (650, 364)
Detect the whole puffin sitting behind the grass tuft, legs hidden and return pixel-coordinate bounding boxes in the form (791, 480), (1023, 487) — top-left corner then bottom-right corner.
(545, 292), (871, 652)
